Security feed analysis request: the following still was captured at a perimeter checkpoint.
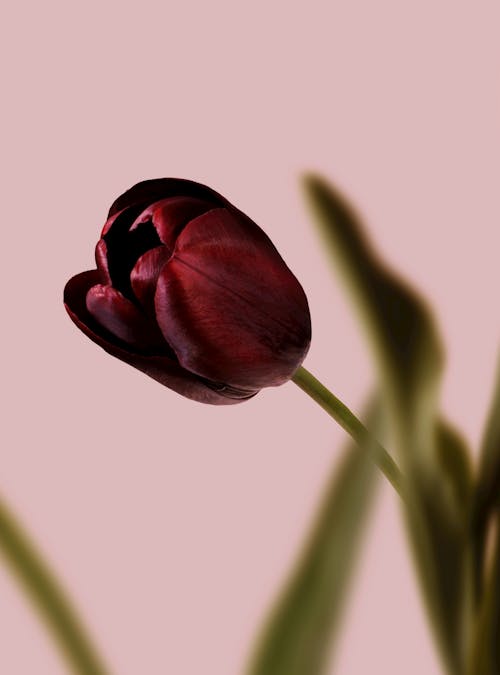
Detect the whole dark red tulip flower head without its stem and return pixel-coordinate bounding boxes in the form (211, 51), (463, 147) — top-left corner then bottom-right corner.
(64, 178), (311, 404)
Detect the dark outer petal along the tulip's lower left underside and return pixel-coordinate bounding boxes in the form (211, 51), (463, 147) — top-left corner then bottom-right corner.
(64, 270), (256, 405)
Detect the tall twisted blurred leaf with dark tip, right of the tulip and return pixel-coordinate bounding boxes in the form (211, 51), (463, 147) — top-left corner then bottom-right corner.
(305, 176), (470, 673)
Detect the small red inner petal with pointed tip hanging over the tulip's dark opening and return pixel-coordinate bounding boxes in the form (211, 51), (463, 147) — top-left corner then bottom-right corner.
(130, 197), (213, 253)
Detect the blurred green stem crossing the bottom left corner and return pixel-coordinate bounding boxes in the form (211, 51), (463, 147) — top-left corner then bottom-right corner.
(0, 501), (109, 675)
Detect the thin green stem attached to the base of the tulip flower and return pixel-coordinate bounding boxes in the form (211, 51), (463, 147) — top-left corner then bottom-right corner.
(292, 367), (403, 496)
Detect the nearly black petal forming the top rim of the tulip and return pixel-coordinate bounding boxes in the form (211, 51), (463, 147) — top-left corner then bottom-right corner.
(108, 178), (229, 218)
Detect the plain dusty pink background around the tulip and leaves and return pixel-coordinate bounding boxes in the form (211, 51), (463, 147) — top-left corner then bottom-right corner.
(0, 0), (500, 675)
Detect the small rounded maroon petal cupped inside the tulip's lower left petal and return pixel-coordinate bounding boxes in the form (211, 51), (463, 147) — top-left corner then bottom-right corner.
(86, 284), (164, 351)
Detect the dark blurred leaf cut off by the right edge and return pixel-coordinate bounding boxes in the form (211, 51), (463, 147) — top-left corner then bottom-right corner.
(472, 356), (500, 603)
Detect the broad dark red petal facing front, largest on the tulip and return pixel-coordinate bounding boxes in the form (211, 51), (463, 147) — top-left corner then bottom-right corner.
(155, 209), (311, 388)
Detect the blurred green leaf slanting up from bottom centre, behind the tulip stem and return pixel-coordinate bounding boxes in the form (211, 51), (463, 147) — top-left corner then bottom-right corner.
(247, 408), (379, 675)
